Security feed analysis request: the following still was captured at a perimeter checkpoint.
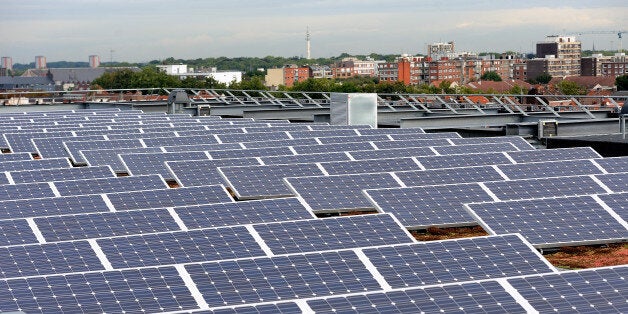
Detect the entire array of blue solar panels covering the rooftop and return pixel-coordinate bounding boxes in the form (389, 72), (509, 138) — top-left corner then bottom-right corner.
(0, 109), (628, 313)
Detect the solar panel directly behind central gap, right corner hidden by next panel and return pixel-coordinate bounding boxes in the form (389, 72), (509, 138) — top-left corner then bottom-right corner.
(285, 173), (400, 212)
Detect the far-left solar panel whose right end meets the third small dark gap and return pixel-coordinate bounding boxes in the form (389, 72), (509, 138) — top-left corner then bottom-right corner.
(9, 166), (115, 183)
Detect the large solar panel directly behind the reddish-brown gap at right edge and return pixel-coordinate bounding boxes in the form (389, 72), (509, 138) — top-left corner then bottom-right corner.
(466, 196), (628, 248)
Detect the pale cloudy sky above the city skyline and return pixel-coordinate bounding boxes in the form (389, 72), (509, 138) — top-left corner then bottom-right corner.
(0, 0), (628, 63)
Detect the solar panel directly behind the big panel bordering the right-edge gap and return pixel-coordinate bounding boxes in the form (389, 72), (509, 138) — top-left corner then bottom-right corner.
(484, 176), (606, 201)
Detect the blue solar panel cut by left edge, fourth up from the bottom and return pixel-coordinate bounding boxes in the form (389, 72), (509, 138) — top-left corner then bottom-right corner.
(0, 195), (109, 219)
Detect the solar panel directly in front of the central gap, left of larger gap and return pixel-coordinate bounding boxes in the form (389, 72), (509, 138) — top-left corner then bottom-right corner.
(253, 214), (415, 255)
